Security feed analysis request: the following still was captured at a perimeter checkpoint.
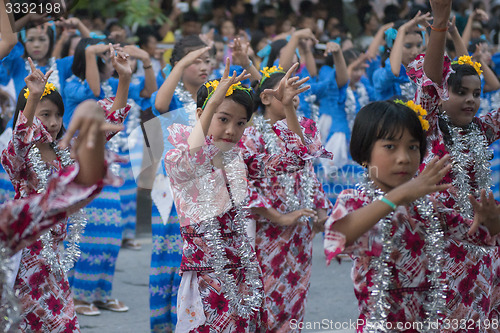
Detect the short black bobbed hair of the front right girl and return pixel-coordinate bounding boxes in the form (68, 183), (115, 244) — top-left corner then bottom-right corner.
(350, 100), (427, 164)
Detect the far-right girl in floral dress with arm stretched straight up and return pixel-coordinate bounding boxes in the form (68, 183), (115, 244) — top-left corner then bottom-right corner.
(411, 0), (500, 321)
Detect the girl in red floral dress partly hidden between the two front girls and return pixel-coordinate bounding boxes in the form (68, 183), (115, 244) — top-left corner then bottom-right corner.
(240, 67), (331, 332)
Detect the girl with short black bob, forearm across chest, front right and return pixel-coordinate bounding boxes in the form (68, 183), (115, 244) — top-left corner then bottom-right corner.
(324, 101), (499, 332)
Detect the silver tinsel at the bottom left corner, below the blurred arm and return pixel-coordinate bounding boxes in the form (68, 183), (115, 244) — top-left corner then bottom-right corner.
(0, 244), (21, 333)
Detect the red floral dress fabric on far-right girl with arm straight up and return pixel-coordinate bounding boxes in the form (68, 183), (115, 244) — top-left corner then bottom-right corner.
(410, 55), (500, 326)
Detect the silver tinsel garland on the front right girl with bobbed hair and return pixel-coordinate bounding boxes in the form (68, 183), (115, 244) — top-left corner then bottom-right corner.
(358, 173), (447, 333)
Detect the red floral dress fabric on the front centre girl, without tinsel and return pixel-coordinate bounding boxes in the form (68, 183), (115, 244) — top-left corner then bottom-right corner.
(165, 124), (324, 332)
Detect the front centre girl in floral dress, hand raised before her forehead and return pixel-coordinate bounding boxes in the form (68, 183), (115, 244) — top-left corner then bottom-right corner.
(165, 60), (332, 332)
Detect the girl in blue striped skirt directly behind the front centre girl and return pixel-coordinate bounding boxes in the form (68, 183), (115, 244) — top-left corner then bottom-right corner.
(148, 35), (212, 332)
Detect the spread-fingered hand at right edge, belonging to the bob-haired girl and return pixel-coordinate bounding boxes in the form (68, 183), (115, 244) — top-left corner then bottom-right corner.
(468, 189), (500, 236)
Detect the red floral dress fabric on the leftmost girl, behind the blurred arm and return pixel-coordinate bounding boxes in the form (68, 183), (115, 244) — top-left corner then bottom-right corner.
(2, 99), (130, 332)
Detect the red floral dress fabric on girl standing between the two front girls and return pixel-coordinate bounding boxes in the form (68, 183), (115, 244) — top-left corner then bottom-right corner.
(240, 118), (332, 332)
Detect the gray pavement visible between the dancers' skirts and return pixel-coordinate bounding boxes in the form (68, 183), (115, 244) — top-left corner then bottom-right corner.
(78, 229), (357, 333)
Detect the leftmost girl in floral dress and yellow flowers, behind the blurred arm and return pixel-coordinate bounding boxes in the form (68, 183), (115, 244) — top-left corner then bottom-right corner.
(2, 50), (130, 332)
